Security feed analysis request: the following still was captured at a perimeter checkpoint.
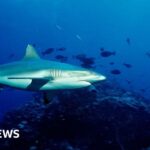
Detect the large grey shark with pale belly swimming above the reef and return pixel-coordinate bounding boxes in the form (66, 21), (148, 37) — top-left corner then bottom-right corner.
(0, 44), (106, 91)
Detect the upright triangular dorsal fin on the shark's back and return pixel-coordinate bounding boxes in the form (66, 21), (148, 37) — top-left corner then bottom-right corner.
(23, 44), (40, 60)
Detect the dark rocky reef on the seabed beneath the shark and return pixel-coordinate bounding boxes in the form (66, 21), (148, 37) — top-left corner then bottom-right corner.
(0, 82), (150, 150)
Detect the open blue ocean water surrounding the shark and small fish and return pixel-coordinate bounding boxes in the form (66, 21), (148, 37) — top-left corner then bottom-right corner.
(0, 0), (150, 116)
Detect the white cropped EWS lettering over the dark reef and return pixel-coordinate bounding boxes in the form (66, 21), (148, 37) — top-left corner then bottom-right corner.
(0, 129), (20, 139)
